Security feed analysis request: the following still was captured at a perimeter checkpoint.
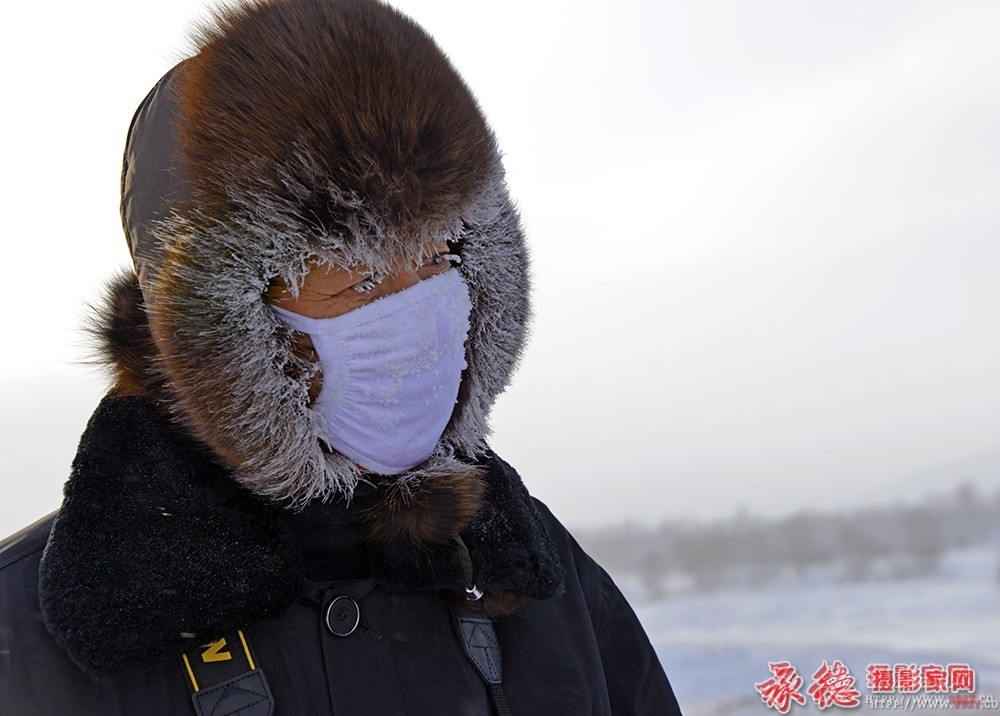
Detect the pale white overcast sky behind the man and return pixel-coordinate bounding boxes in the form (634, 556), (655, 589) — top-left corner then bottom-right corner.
(0, 0), (1000, 532)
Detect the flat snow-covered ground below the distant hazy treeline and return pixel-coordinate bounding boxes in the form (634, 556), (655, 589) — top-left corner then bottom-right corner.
(636, 542), (1000, 716)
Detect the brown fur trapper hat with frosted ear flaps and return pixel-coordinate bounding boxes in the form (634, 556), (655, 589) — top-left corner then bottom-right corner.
(105, 0), (528, 532)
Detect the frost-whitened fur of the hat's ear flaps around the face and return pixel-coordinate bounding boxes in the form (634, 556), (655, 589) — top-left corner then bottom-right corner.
(139, 170), (528, 504)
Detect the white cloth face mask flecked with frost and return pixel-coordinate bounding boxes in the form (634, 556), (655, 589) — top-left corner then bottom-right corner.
(275, 269), (472, 475)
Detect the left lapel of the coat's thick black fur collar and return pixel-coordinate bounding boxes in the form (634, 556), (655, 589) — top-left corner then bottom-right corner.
(39, 398), (302, 674)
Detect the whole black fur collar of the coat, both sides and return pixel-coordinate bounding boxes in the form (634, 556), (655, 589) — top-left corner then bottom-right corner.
(40, 397), (562, 675)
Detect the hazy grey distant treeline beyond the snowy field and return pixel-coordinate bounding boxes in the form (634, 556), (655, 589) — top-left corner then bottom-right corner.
(576, 484), (1000, 598)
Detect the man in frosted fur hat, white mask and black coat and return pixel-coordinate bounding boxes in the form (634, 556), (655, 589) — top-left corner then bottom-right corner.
(0, 0), (678, 716)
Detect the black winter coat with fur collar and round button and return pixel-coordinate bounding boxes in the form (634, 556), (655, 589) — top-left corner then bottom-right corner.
(0, 399), (679, 716)
